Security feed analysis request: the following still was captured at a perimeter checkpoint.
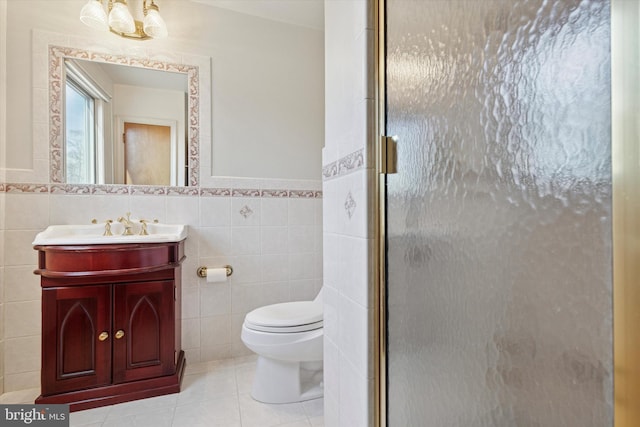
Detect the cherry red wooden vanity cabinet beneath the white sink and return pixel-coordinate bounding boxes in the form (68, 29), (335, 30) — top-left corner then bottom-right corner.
(34, 240), (185, 411)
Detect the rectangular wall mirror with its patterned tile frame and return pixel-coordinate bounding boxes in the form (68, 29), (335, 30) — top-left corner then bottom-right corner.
(49, 46), (200, 186)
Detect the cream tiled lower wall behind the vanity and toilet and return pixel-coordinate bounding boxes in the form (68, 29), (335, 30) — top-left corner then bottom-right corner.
(0, 179), (322, 392)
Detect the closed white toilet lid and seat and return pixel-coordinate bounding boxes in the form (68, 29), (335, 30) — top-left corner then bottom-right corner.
(244, 301), (322, 332)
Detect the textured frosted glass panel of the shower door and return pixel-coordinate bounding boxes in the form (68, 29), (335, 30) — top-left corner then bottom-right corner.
(385, 0), (613, 427)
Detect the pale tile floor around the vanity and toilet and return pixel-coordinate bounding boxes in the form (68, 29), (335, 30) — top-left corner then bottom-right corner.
(0, 356), (324, 427)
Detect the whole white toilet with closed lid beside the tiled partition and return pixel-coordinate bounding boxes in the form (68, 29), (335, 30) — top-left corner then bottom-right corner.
(241, 290), (324, 403)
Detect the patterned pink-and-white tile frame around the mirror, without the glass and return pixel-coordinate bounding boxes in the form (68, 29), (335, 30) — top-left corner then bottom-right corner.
(49, 46), (200, 187)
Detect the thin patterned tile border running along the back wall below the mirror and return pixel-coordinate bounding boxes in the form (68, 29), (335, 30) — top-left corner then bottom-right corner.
(0, 183), (322, 199)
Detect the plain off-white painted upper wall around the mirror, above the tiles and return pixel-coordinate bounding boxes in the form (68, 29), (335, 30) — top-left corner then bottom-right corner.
(6, 0), (324, 179)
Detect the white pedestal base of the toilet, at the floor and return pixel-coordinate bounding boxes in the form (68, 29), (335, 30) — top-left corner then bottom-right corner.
(251, 356), (324, 403)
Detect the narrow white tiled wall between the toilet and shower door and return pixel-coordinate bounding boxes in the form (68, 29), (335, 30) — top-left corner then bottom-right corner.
(323, 0), (376, 426)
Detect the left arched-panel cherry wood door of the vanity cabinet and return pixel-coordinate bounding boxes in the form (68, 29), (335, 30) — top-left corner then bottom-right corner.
(41, 285), (111, 396)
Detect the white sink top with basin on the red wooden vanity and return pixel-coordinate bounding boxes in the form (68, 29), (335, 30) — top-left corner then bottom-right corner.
(33, 222), (188, 245)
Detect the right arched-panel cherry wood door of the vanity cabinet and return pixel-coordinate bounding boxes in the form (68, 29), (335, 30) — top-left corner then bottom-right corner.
(113, 281), (176, 383)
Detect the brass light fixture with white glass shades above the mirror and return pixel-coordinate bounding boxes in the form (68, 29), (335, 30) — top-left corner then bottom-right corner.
(80, 0), (168, 40)
